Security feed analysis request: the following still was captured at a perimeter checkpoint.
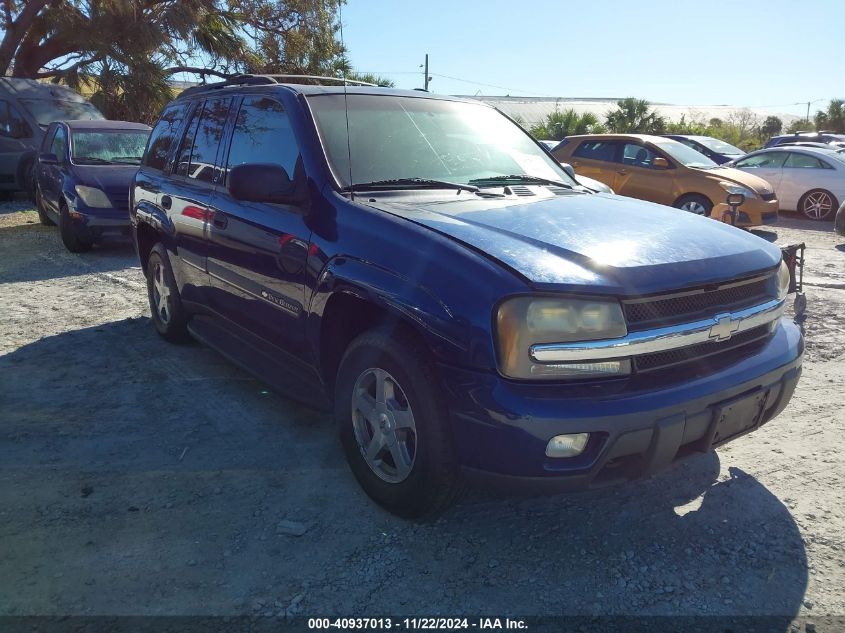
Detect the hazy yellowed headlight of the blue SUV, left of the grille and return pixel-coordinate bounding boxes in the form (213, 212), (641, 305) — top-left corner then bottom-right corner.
(496, 297), (631, 380)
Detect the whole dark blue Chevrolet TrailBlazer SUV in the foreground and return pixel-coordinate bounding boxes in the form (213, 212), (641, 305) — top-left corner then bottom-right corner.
(130, 76), (804, 517)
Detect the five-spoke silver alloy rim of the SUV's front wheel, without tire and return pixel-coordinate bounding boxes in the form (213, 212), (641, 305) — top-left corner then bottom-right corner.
(352, 368), (417, 484)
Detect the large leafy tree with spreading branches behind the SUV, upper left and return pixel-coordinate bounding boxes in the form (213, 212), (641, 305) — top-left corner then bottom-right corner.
(0, 0), (382, 121)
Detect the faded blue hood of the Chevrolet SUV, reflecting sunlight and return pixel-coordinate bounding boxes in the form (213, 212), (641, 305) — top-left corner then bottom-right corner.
(367, 188), (781, 296)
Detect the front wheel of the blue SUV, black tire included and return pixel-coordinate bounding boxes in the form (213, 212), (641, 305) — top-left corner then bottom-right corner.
(335, 328), (461, 519)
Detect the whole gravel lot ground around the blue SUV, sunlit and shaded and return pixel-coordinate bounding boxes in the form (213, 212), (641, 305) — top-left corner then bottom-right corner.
(0, 202), (845, 630)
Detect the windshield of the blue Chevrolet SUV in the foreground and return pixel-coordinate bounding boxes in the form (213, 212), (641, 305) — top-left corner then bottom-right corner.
(309, 94), (575, 187)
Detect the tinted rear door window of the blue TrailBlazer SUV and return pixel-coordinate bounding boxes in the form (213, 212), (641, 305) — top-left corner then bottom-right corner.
(176, 97), (232, 183)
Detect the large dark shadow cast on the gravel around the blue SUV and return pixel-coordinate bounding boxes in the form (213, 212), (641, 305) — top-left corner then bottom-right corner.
(0, 318), (807, 616)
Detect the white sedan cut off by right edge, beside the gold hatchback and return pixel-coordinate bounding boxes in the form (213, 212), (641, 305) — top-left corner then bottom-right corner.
(728, 145), (845, 220)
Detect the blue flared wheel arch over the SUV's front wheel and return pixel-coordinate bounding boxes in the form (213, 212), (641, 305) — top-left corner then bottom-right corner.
(308, 256), (471, 360)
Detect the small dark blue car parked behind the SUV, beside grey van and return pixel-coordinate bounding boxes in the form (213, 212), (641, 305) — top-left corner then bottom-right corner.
(35, 121), (151, 253)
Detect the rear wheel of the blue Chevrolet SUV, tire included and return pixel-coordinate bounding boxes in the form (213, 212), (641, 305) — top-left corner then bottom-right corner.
(146, 243), (188, 343)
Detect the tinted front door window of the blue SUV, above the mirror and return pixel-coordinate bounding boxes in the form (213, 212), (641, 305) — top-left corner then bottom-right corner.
(227, 97), (299, 178)
